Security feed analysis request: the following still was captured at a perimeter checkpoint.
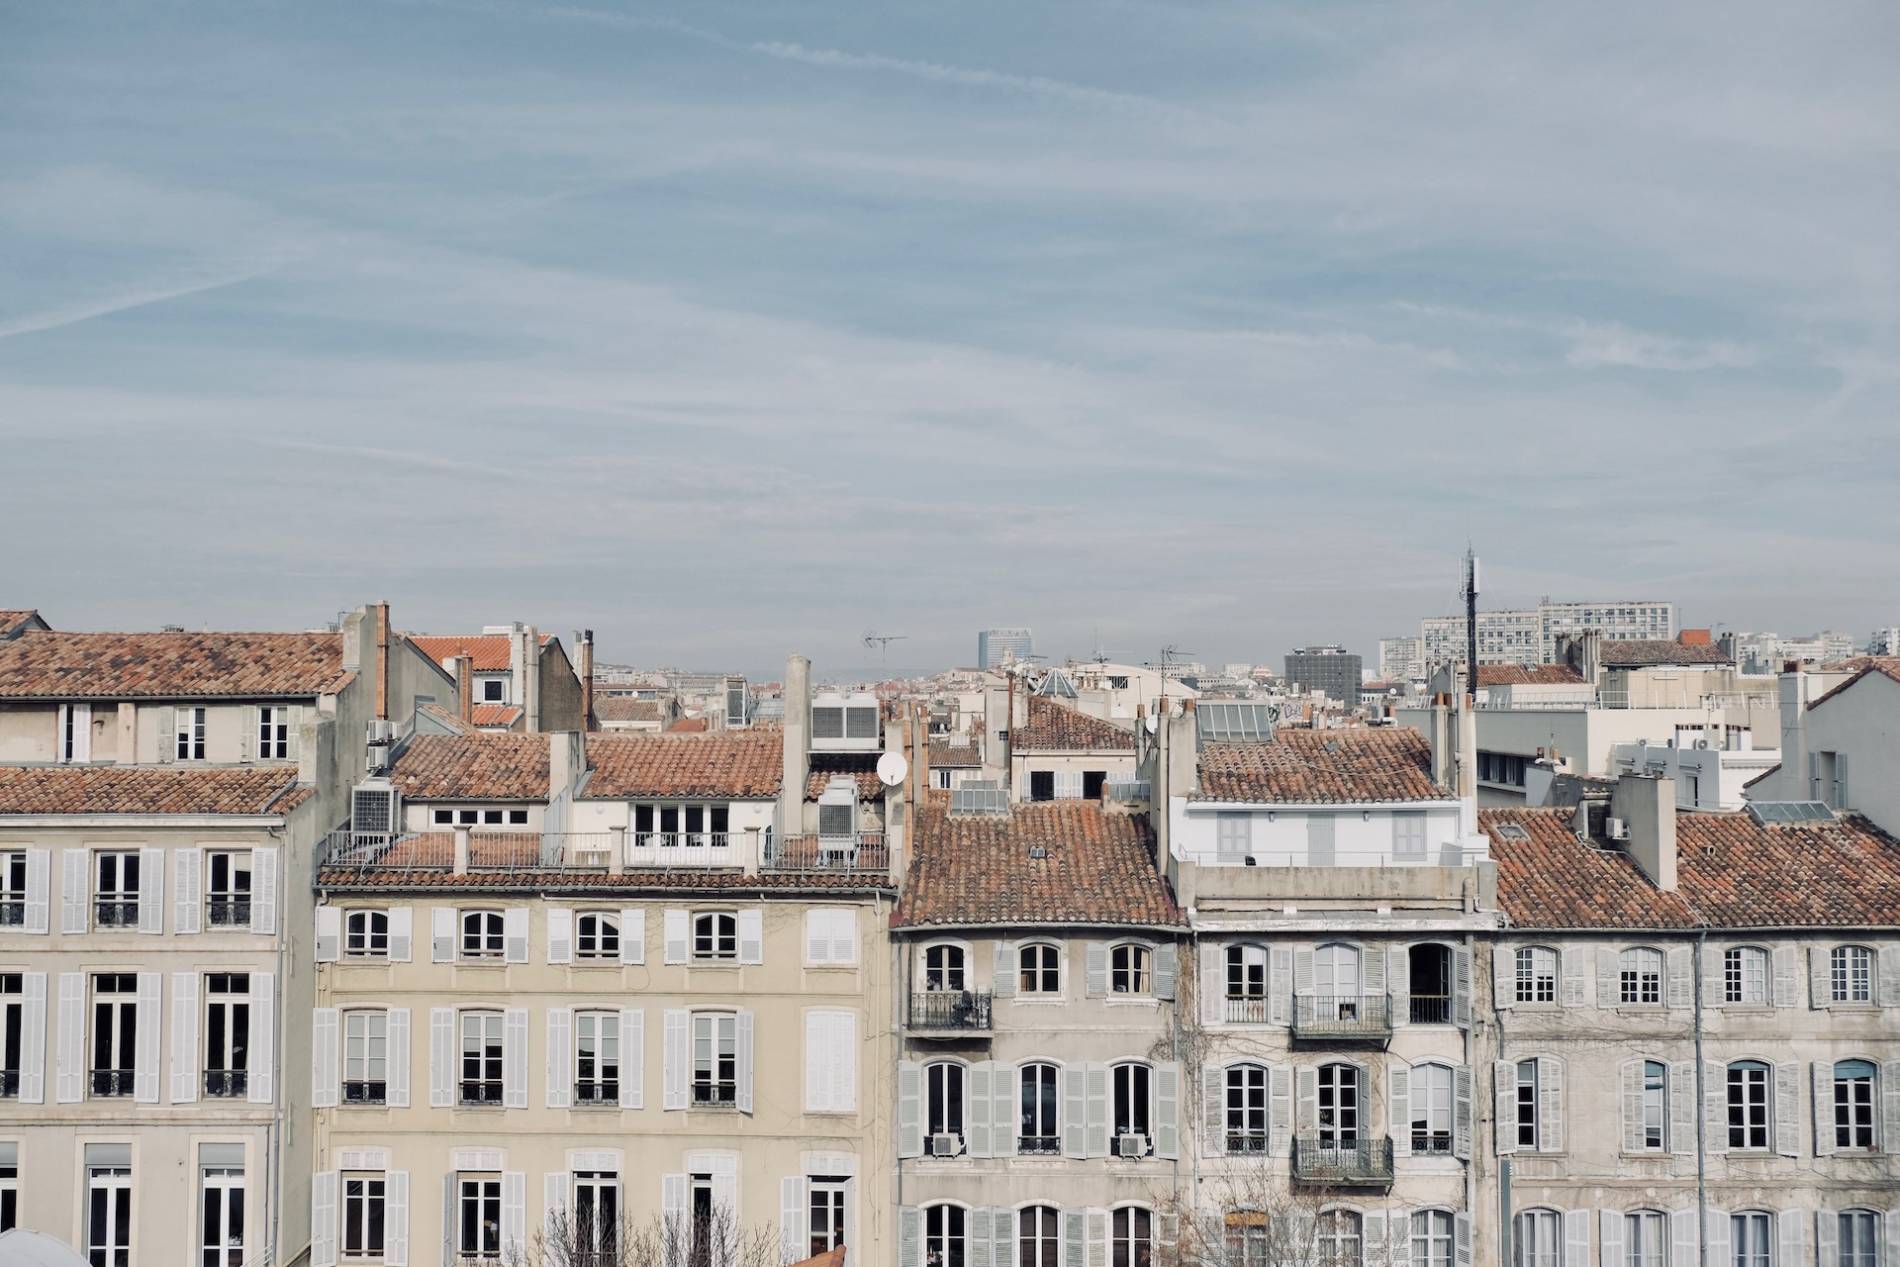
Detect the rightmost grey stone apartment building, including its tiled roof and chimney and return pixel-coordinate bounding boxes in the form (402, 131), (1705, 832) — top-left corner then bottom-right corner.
(1482, 777), (1900, 1267)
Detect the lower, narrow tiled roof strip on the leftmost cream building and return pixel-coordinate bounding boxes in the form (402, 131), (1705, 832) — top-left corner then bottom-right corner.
(0, 766), (315, 815)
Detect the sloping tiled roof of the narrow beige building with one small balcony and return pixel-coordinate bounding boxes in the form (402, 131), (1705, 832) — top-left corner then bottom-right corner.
(891, 792), (1182, 927)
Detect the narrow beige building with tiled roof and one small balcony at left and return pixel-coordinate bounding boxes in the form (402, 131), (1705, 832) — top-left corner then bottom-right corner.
(893, 788), (1189, 1267)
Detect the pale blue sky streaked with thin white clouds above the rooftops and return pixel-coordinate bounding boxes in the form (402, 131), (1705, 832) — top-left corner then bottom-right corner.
(0, 0), (1900, 674)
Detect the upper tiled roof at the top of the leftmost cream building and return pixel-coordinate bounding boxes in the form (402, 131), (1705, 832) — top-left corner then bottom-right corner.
(0, 631), (350, 699)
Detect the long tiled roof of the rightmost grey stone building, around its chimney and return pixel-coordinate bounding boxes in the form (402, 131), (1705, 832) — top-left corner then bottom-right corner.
(1478, 809), (1900, 929)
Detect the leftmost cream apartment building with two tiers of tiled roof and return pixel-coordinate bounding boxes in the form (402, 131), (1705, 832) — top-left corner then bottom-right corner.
(0, 608), (447, 1267)
